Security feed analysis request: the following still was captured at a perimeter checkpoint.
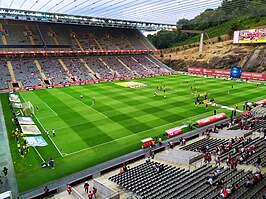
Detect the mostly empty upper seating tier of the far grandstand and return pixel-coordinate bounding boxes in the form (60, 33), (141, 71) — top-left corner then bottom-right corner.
(3, 20), (155, 50)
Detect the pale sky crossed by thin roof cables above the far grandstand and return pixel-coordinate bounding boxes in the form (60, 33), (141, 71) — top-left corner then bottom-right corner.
(0, 0), (221, 24)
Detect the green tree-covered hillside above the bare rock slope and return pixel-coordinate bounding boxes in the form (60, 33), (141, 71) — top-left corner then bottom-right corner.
(148, 0), (266, 49)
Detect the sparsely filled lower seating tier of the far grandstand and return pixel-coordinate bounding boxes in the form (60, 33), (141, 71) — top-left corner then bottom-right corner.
(0, 55), (171, 89)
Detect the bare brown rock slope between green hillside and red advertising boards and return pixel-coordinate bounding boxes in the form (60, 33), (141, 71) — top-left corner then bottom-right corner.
(157, 41), (266, 73)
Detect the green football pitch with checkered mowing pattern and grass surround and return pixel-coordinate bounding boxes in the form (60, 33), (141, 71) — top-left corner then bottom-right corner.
(1, 75), (266, 192)
